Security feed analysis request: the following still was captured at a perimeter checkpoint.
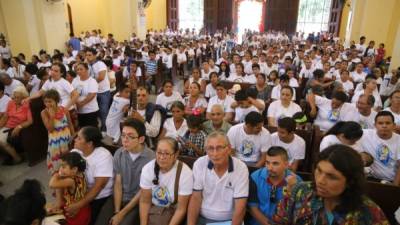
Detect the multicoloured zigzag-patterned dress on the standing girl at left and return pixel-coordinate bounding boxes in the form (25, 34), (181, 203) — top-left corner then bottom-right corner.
(47, 107), (71, 174)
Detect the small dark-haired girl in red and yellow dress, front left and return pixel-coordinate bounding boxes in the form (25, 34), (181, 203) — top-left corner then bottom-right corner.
(49, 152), (91, 225)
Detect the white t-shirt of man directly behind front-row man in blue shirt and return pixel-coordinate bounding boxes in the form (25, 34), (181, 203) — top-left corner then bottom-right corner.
(271, 132), (306, 164)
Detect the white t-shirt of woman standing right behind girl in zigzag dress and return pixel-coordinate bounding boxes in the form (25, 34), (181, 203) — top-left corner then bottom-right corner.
(42, 78), (76, 107)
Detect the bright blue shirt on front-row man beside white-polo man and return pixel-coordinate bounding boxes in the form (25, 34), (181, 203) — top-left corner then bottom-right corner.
(247, 167), (302, 225)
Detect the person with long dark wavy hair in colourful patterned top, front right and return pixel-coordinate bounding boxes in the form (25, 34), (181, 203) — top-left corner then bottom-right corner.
(273, 145), (389, 225)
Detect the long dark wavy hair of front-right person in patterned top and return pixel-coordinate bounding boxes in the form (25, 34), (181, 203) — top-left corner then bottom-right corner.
(314, 145), (366, 212)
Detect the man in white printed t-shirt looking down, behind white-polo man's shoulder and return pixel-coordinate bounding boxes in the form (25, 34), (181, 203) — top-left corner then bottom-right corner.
(227, 112), (271, 167)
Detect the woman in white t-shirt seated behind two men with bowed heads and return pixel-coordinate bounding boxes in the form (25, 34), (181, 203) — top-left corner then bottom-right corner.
(268, 86), (301, 127)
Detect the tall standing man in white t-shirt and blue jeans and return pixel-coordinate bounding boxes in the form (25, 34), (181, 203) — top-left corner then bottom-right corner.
(86, 48), (111, 132)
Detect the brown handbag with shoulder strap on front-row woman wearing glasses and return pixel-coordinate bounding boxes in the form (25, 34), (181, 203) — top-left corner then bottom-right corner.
(148, 161), (182, 225)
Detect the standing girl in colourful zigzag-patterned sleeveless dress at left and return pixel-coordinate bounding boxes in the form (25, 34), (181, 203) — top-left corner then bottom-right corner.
(41, 90), (74, 174)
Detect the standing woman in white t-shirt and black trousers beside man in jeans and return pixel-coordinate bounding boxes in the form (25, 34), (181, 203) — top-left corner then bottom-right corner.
(72, 63), (99, 127)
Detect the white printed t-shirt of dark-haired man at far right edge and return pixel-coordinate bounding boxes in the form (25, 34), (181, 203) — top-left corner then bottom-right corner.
(360, 129), (400, 181)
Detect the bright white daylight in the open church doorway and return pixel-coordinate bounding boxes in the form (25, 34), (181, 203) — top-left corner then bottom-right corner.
(238, 0), (262, 43)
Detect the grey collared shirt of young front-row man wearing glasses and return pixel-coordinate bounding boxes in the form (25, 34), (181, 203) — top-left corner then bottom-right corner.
(113, 147), (155, 202)
